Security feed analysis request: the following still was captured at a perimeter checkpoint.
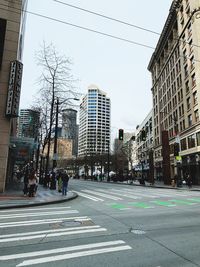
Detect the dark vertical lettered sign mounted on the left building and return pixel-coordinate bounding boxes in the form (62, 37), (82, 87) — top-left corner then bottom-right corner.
(6, 60), (23, 118)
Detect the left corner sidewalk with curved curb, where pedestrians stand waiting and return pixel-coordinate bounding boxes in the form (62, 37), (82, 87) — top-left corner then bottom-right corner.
(0, 185), (78, 210)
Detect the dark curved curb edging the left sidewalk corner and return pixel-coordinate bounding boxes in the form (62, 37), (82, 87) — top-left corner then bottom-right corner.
(0, 192), (78, 210)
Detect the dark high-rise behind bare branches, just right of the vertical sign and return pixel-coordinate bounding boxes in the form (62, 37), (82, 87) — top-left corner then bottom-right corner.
(18, 109), (40, 140)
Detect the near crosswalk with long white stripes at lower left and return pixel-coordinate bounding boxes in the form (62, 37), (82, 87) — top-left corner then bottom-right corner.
(0, 206), (132, 267)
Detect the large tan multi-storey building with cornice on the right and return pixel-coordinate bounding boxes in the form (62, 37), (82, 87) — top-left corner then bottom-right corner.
(148, 0), (200, 184)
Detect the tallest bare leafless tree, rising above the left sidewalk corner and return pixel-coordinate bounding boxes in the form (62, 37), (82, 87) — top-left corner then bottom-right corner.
(36, 43), (78, 185)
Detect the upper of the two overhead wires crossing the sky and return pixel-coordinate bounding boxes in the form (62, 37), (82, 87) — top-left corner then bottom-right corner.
(53, 0), (160, 35)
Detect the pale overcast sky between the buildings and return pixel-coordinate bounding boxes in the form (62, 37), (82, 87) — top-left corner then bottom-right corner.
(20, 0), (172, 138)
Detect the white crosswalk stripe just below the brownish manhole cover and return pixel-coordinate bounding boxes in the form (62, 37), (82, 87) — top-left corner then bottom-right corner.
(0, 225), (101, 240)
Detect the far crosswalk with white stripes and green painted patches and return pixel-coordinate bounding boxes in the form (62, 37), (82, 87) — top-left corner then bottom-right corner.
(72, 187), (200, 210)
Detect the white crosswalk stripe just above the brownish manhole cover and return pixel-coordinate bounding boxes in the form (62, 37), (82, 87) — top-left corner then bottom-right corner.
(0, 217), (91, 228)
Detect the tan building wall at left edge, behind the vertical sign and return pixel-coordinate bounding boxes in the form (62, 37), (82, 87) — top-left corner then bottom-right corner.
(0, 0), (27, 192)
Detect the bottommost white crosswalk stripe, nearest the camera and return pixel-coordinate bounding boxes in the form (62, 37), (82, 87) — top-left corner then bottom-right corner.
(16, 246), (132, 267)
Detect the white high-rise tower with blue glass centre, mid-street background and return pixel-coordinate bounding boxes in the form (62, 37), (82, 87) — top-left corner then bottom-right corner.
(78, 85), (110, 156)
